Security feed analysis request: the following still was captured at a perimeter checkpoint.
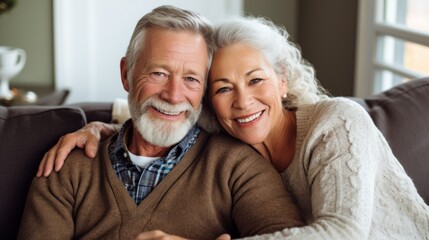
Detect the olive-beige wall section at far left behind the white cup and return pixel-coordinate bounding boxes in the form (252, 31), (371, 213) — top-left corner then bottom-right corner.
(0, 0), (54, 87)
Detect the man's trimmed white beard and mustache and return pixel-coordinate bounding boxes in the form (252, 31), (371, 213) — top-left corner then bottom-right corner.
(128, 94), (202, 147)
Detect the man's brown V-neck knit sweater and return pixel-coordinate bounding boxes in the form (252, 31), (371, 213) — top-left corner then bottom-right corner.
(18, 131), (303, 239)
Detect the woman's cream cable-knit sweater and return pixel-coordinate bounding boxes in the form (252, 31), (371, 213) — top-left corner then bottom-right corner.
(242, 98), (429, 240)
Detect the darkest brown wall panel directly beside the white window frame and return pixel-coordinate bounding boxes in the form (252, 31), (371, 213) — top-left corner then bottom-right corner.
(297, 0), (356, 96)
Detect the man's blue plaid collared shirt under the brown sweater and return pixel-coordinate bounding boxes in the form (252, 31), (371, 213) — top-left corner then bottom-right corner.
(109, 120), (200, 204)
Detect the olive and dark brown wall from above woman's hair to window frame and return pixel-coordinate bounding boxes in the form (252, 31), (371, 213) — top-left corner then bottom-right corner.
(244, 0), (358, 96)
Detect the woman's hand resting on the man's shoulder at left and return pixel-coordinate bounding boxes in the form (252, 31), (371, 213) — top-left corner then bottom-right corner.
(37, 122), (116, 177)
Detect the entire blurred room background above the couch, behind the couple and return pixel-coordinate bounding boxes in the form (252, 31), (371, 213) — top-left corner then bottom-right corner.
(0, 0), (429, 103)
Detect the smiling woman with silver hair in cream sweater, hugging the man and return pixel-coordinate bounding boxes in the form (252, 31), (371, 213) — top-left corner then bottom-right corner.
(39, 17), (429, 239)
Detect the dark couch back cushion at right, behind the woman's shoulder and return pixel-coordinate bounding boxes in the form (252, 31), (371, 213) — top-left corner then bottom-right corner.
(364, 78), (429, 203)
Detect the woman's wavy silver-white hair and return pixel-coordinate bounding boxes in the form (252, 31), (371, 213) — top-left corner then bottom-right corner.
(199, 16), (328, 132)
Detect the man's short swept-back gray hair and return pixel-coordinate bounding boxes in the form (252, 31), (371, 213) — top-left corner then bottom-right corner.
(125, 5), (213, 80)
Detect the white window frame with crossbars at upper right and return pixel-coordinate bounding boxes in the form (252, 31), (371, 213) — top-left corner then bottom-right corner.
(354, 0), (429, 97)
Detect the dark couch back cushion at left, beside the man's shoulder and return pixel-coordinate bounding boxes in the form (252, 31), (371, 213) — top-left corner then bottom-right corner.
(0, 106), (86, 239)
